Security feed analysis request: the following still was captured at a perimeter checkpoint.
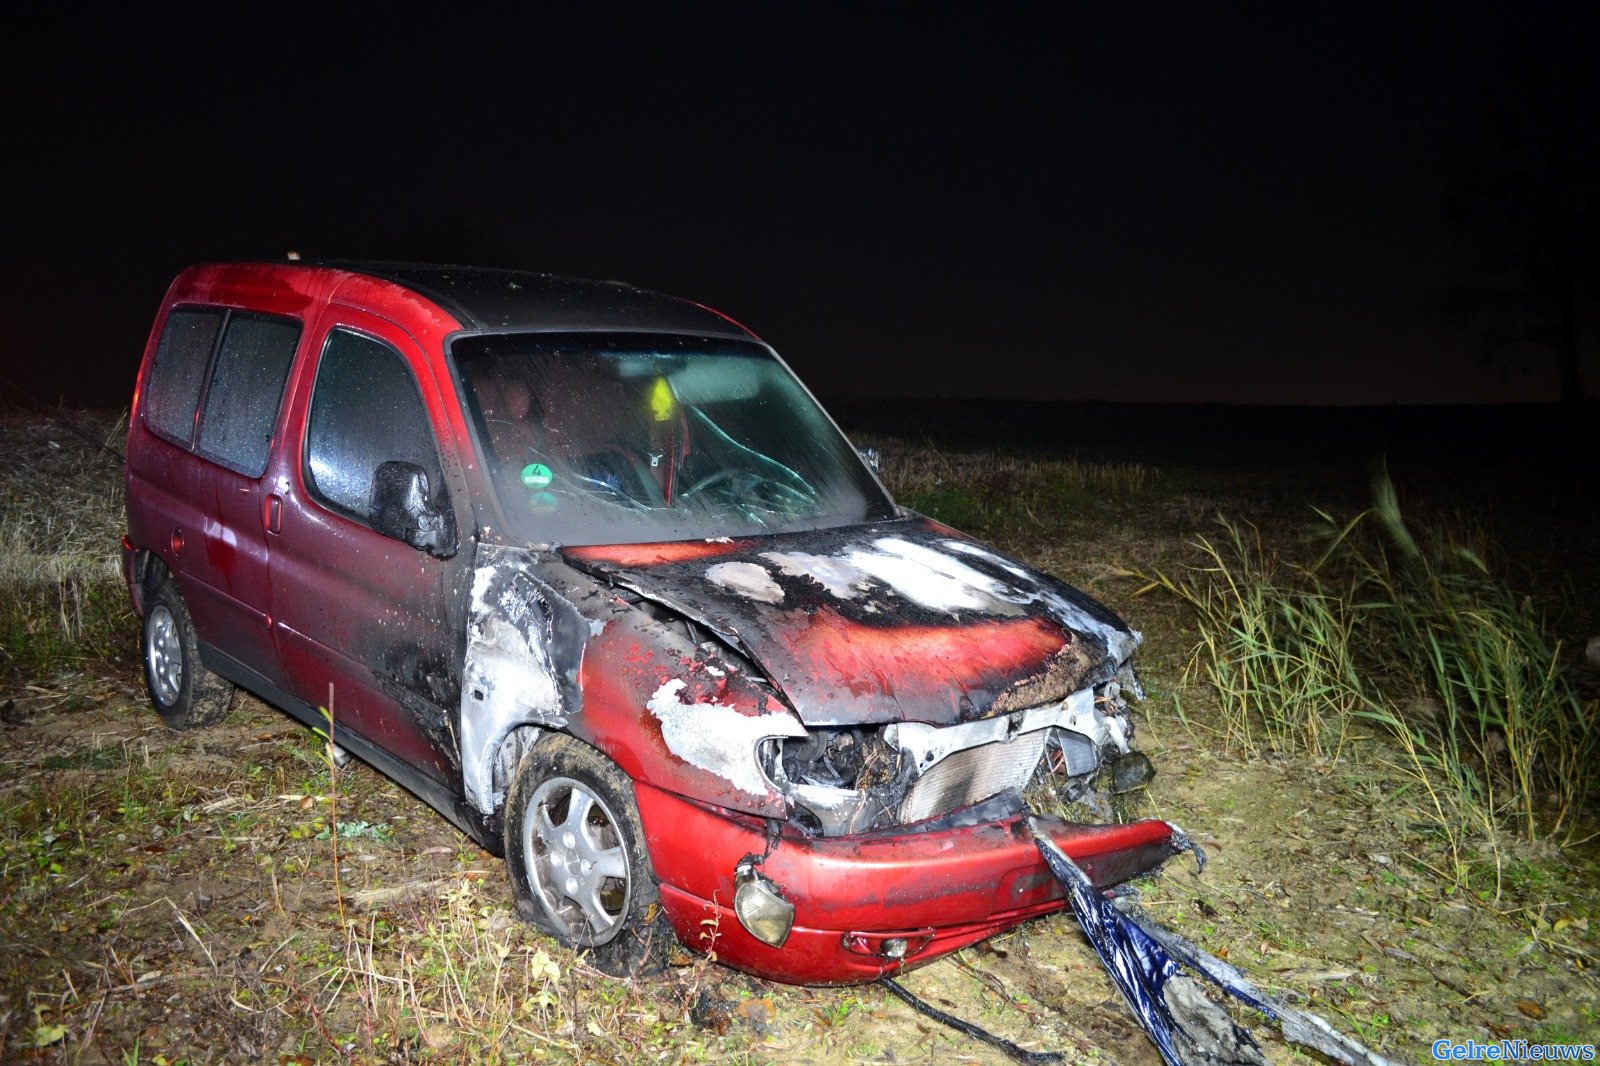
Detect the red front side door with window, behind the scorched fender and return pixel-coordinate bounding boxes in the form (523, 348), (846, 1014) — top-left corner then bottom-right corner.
(267, 306), (472, 783)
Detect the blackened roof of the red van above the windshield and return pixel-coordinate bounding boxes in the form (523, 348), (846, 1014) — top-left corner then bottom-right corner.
(315, 262), (754, 338)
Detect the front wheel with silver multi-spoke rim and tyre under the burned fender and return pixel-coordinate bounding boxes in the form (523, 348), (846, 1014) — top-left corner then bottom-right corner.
(506, 733), (674, 976)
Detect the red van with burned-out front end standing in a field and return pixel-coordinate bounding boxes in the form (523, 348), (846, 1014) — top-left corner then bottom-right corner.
(123, 262), (1184, 983)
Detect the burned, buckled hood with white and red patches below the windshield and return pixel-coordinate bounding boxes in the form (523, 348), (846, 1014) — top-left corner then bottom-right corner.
(562, 517), (1139, 727)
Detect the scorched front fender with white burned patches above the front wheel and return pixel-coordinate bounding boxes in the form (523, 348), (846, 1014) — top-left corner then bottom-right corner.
(458, 543), (805, 818)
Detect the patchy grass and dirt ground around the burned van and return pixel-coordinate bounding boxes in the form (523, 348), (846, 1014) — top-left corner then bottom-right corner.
(0, 409), (1600, 1066)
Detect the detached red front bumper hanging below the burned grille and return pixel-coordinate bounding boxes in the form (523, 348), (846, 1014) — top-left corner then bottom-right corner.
(635, 784), (1182, 984)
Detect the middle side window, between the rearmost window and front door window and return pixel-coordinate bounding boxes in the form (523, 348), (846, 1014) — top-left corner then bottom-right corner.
(198, 312), (299, 477)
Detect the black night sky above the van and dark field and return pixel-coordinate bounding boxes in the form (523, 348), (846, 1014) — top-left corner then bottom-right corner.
(0, 3), (1600, 403)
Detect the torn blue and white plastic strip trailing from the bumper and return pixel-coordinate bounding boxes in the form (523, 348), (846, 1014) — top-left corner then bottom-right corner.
(1029, 820), (1394, 1066)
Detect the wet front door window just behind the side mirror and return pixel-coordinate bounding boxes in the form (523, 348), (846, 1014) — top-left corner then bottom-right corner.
(306, 330), (445, 525)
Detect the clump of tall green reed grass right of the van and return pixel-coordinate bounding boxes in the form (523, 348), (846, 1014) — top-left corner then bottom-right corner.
(1146, 477), (1600, 855)
